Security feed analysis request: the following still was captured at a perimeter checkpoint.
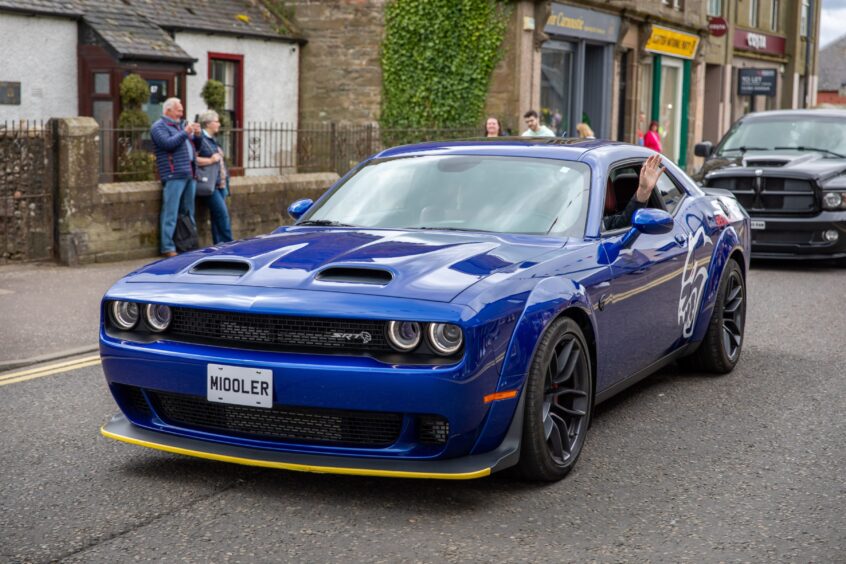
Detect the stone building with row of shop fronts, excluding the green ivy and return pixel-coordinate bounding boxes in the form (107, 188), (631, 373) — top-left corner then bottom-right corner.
(287, 0), (820, 168)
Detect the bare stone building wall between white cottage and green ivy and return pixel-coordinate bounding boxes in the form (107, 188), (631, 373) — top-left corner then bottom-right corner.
(285, 0), (385, 123)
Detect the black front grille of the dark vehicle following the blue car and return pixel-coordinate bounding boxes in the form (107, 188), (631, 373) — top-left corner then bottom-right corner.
(708, 176), (819, 216)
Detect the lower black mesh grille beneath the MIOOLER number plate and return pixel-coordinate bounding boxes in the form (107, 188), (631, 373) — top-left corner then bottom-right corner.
(147, 391), (403, 447)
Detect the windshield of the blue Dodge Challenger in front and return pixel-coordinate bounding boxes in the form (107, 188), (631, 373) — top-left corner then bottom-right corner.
(303, 155), (590, 237)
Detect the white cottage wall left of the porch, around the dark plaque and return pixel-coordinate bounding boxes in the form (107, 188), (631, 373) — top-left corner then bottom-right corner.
(0, 12), (79, 124)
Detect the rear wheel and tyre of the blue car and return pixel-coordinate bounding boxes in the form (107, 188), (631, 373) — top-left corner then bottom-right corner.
(681, 259), (746, 374)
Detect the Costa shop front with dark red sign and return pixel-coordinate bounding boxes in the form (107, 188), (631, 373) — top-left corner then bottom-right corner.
(732, 29), (787, 120)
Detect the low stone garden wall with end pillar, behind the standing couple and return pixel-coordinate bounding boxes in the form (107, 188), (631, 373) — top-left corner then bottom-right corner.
(52, 118), (338, 265)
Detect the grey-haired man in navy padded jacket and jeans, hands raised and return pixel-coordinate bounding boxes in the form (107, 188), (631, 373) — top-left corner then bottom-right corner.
(150, 98), (200, 257)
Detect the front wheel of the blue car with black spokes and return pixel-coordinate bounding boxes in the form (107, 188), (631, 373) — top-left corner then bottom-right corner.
(518, 317), (593, 482)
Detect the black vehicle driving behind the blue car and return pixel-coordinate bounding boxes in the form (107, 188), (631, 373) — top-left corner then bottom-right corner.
(694, 110), (846, 263)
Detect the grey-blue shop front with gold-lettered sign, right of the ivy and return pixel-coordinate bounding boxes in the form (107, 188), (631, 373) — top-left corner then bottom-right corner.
(540, 3), (620, 138)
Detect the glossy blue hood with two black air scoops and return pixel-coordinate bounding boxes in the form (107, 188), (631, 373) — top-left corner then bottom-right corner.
(125, 227), (566, 302)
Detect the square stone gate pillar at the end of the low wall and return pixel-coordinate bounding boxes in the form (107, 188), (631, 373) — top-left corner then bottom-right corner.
(54, 117), (100, 266)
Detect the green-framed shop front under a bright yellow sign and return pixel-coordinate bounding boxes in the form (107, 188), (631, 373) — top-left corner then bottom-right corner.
(639, 25), (699, 168)
